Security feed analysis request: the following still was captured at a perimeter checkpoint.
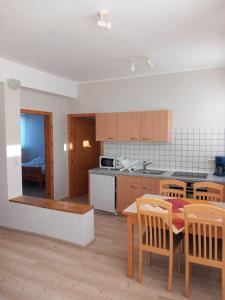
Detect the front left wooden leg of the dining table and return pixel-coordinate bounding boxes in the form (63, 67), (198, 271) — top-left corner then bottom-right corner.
(127, 216), (134, 278)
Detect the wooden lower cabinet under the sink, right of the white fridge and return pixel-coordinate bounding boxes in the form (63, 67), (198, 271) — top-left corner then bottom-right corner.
(117, 175), (159, 212)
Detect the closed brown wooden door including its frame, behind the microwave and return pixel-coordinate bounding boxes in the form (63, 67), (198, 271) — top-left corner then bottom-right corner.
(68, 114), (100, 204)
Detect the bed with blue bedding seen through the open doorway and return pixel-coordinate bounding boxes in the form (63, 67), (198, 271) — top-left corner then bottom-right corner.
(22, 156), (45, 189)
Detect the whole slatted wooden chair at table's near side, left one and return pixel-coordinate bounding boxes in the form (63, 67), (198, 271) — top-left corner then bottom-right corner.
(136, 198), (183, 291)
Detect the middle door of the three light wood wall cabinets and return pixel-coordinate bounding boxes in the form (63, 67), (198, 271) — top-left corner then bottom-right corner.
(117, 112), (141, 141)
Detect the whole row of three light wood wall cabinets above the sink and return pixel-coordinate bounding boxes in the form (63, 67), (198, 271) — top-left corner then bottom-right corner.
(96, 110), (171, 142)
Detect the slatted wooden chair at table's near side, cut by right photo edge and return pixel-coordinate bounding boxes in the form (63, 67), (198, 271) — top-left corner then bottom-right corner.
(184, 204), (225, 299)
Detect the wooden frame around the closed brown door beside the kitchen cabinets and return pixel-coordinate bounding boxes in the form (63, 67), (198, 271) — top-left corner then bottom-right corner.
(67, 113), (103, 198)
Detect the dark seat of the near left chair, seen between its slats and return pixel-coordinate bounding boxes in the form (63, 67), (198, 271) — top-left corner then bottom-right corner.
(143, 228), (184, 251)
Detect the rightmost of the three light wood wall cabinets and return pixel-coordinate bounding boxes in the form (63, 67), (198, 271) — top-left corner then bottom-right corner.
(141, 110), (171, 142)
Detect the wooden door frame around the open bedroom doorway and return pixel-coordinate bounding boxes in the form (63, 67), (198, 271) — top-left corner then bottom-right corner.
(20, 109), (54, 200)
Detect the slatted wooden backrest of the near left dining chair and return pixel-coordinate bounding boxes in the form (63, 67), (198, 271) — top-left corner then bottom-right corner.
(136, 198), (173, 255)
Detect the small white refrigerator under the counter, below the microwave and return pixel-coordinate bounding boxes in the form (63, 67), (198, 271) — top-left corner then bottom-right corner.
(90, 173), (116, 214)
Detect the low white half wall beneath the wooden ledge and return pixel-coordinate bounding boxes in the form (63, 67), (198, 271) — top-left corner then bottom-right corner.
(9, 202), (94, 246)
